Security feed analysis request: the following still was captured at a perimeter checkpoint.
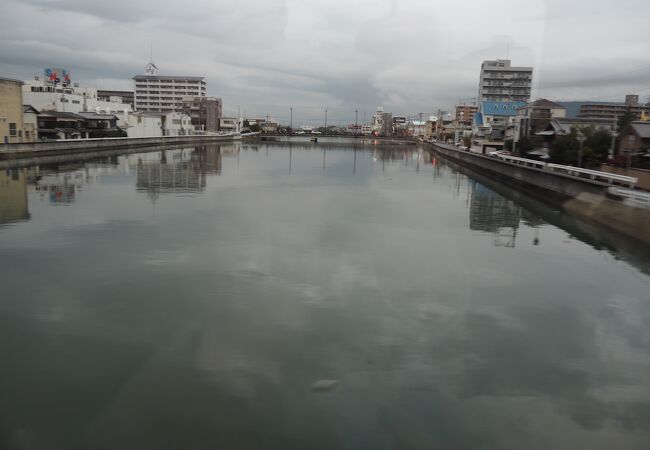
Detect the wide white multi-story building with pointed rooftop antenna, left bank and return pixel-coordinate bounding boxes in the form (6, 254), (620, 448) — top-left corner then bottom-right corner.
(133, 63), (207, 112)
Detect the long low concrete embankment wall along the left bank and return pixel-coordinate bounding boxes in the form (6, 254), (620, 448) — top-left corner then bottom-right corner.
(0, 136), (238, 160)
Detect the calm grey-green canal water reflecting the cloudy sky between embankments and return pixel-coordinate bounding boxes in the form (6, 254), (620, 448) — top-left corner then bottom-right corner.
(0, 144), (650, 450)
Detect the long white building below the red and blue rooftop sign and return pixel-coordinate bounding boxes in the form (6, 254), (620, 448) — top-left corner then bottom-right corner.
(23, 76), (132, 114)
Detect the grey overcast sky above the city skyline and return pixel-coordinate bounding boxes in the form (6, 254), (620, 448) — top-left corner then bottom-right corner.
(0, 0), (650, 125)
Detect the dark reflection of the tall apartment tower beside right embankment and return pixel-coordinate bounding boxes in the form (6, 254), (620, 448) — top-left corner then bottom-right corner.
(469, 181), (522, 247)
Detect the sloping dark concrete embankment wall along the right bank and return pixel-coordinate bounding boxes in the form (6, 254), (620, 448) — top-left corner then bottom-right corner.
(430, 145), (650, 245)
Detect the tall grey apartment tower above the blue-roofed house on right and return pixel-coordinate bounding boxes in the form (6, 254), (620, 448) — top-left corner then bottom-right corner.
(478, 59), (533, 103)
